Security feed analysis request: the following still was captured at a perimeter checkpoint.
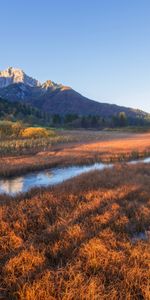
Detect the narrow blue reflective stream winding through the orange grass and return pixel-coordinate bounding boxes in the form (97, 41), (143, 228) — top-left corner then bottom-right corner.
(0, 157), (150, 196)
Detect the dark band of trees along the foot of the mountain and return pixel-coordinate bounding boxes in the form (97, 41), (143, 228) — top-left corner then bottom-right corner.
(0, 98), (150, 129)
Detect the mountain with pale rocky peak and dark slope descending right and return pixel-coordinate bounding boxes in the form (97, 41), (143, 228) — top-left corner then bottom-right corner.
(0, 67), (148, 118)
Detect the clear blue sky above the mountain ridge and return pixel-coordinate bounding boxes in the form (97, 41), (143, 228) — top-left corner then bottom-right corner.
(0, 0), (150, 112)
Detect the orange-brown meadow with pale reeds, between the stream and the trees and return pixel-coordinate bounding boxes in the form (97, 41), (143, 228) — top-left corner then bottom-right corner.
(0, 130), (150, 177)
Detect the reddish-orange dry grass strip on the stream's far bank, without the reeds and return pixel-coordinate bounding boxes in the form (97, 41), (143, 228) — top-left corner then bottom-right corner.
(0, 131), (150, 176)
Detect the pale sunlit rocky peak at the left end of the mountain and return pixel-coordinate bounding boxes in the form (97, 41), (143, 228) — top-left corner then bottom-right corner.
(0, 67), (41, 88)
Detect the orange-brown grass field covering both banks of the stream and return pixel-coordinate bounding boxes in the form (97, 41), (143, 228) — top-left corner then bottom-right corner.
(0, 131), (150, 300)
